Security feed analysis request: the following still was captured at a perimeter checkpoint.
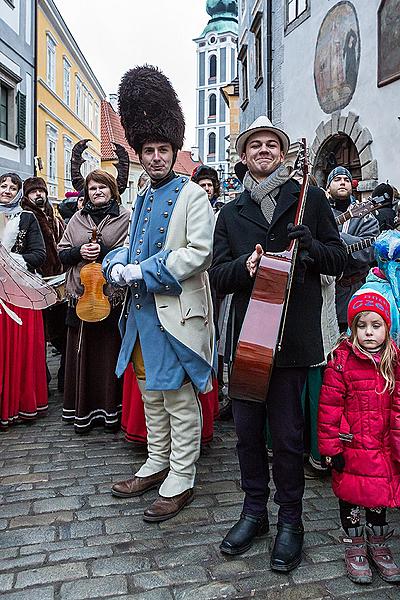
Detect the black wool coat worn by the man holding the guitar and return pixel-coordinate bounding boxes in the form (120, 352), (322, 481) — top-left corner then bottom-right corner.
(209, 179), (347, 367)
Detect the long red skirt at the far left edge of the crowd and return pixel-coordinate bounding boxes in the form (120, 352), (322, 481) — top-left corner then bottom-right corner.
(0, 306), (47, 427)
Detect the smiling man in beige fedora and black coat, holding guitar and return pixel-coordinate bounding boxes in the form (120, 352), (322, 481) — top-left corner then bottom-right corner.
(210, 116), (346, 572)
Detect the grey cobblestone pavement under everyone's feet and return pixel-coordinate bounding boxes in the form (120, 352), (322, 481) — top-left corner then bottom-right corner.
(0, 358), (400, 600)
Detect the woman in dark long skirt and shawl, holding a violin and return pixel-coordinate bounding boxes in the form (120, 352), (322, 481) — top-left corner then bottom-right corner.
(58, 170), (129, 433)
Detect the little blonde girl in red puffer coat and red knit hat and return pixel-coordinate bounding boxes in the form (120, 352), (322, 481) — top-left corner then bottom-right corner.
(318, 290), (400, 583)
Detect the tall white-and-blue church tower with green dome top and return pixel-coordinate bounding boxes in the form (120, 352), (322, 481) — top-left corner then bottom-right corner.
(194, 0), (238, 179)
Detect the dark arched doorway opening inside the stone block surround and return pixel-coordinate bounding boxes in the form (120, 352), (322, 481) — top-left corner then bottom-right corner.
(313, 133), (361, 195)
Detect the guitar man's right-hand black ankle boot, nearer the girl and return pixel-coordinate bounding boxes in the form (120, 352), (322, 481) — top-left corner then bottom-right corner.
(270, 523), (304, 573)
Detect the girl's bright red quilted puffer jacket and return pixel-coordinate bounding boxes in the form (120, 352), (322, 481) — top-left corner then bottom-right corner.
(318, 340), (400, 508)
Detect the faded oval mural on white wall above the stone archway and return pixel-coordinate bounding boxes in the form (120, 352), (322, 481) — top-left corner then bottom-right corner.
(314, 1), (360, 114)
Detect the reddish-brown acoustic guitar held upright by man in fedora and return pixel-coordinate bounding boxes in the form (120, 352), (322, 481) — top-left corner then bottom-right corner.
(229, 138), (309, 403)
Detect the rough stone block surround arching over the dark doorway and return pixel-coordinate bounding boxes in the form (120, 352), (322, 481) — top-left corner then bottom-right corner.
(310, 111), (378, 192)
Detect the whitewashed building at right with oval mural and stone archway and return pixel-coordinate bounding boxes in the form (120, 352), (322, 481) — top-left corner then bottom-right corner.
(239, 0), (400, 195)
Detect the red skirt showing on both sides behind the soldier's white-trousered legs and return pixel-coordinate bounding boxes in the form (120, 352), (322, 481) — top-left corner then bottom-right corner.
(121, 363), (219, 444)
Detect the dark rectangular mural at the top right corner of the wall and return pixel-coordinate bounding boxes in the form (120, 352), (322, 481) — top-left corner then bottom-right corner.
(378, 0), (400, 86)
